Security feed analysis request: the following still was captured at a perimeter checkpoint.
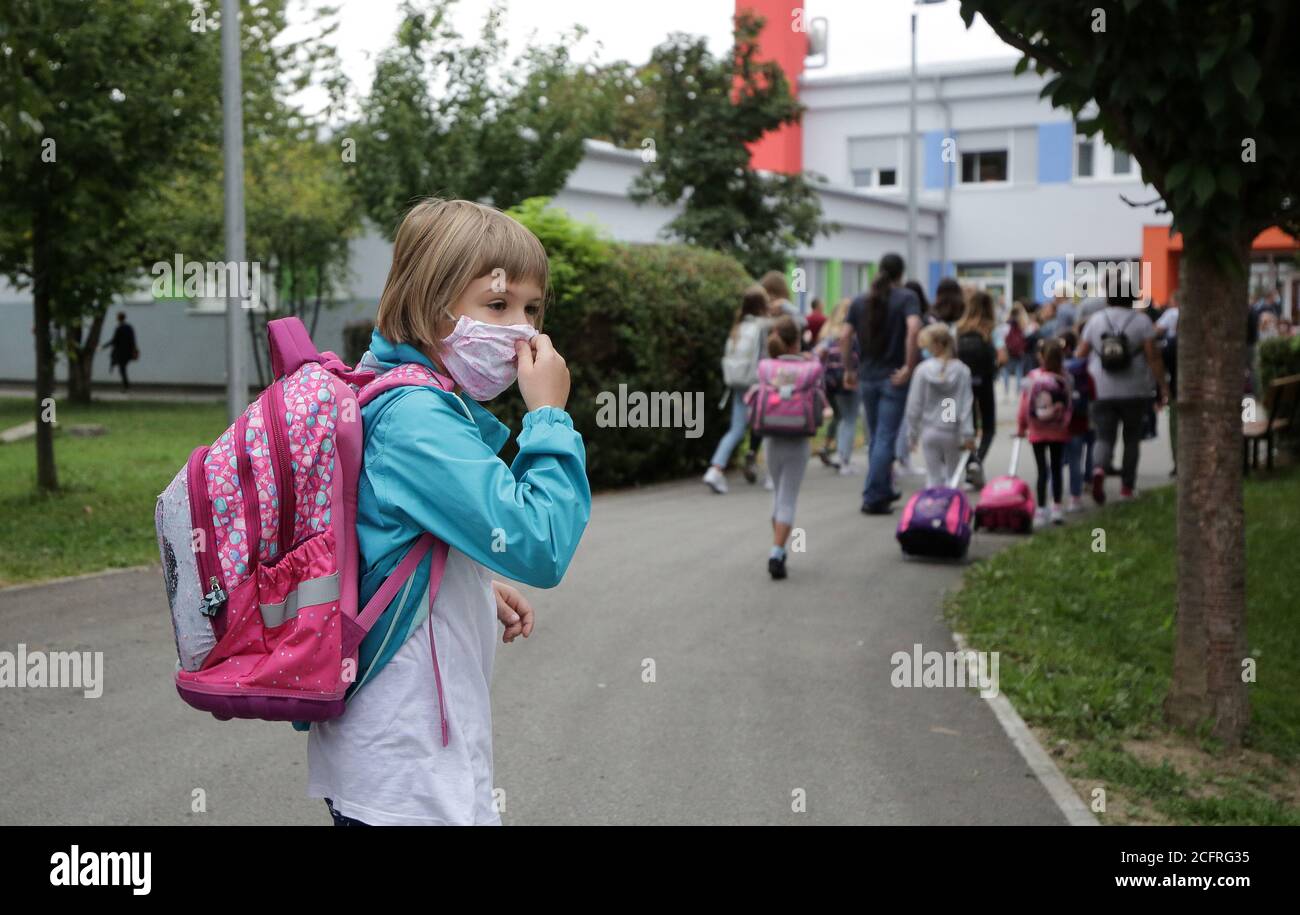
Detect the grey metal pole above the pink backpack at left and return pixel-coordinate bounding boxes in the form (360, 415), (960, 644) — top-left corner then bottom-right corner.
(221, 0), (244, 422)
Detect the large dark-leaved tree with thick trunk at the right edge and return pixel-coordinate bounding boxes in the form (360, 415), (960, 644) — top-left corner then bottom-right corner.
(962, 0), (1300, 745)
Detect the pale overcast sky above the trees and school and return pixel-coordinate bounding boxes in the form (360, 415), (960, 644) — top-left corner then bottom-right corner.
(284, 0), (1018, 113)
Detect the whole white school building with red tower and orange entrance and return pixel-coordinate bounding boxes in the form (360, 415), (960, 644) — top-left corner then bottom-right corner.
(0, 0), (1300, 386)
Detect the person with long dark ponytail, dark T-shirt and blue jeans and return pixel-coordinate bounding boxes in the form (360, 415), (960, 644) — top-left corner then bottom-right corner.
(840, 253), (920, 515)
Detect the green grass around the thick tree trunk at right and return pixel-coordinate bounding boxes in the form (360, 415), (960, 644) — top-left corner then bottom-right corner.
(946, 470), (1300, 824)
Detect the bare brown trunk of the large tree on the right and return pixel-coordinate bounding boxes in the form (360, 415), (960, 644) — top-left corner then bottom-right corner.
(1165, 240), (1251, 746)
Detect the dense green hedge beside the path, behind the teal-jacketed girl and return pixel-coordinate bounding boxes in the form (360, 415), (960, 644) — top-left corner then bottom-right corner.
(332, 198), (751, 489)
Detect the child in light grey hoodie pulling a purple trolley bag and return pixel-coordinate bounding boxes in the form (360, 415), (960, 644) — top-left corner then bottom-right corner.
(905, 324), (975, 486)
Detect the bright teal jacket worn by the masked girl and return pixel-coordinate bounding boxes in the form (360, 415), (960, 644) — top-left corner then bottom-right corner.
(294, 330), (592, 730)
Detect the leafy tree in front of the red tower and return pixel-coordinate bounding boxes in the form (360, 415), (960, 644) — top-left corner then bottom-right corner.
(633, 13), (832, 276)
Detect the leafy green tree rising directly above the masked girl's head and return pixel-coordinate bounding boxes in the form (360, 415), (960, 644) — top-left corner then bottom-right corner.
(348, 0), (589, 233)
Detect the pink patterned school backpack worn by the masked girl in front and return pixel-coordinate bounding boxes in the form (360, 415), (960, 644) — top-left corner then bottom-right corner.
(153, 317), (452, 727)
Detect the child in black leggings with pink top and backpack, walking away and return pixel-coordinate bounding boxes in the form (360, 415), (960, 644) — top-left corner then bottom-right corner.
(1017, 337), (1073, 528)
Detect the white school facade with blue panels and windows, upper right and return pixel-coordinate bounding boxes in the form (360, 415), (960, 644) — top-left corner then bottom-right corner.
(800, 58), (1169, 302)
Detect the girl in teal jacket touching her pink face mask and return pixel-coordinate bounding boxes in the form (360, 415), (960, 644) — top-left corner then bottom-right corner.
(307, 200), (592, 825)
